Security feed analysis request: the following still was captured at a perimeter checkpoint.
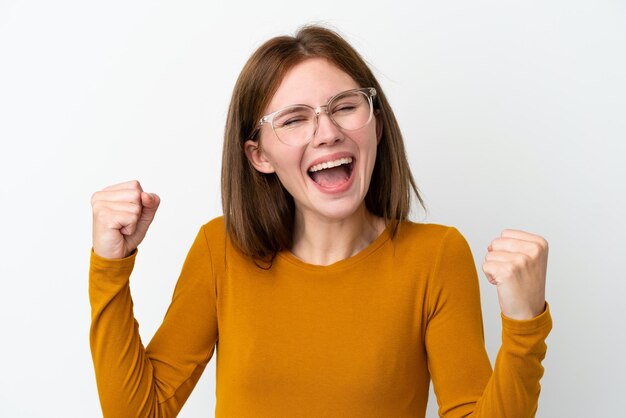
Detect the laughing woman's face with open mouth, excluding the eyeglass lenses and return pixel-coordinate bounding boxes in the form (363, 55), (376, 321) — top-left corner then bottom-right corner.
(245, 58), (378, 221)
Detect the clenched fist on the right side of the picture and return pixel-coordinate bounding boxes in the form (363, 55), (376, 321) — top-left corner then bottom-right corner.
(483, 229), (548, 320)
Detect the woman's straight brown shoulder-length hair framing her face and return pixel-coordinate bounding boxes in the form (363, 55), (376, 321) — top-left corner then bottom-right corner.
(222, 26), (425, 262)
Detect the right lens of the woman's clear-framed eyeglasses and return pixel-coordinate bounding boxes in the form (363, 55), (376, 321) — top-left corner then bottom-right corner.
(328, 91), (372, 131)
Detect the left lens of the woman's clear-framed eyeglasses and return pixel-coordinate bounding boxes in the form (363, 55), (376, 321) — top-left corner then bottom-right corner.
(274, 106), (315, 146)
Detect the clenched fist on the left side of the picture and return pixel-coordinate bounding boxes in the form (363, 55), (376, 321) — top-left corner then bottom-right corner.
(91, 180), (161, 258)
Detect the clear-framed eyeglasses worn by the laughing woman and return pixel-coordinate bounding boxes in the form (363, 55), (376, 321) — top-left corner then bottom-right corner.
(250, 87), (376, 147)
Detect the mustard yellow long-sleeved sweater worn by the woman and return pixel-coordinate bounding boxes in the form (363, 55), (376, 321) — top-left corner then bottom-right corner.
(89, 217), (552, 418)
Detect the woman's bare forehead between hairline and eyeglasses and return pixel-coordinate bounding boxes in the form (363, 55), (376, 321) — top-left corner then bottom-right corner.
(266, 57), (360, 113)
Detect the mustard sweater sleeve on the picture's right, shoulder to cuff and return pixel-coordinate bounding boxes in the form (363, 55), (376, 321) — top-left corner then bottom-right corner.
(426, 227), (552, 418)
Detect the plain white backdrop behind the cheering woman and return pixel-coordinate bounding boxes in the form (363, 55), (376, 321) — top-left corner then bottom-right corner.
(0, 0), (626, 418)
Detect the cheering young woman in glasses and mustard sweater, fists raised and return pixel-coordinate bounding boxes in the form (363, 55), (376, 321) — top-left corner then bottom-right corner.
(89, 26), (552, 418)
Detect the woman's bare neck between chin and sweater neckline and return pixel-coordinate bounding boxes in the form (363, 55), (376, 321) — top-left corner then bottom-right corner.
(291, 205), (385, 266)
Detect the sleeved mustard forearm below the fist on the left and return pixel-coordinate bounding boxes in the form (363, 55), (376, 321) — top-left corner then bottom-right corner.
(89, 253), (175, 417)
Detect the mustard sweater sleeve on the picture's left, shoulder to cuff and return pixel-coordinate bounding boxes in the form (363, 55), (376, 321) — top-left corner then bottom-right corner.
(89, 228), (218, 418)
